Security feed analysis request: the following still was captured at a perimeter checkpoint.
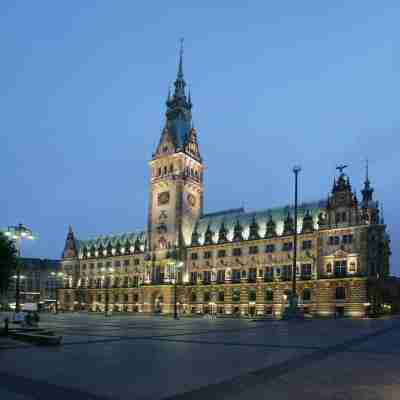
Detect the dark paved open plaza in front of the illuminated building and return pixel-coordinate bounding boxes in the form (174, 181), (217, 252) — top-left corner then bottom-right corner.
(0, 314), (400, 400)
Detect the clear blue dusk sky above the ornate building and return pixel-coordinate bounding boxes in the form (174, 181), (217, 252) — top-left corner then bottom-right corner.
(0, 0), (400, 275)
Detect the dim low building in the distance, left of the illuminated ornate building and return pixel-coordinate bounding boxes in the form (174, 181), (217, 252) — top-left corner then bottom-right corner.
(7, 258), (61, 308)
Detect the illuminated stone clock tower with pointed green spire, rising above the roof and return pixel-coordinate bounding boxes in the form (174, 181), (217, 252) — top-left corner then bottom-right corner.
(148, 41), (203, 259)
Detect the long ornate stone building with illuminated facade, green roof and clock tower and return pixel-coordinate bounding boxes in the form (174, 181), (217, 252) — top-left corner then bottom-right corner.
(59, 47), (390, 317)
